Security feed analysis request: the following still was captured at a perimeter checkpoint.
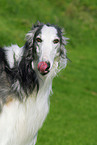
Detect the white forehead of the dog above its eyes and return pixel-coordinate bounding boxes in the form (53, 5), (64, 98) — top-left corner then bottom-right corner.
(41, 25), (58, 40)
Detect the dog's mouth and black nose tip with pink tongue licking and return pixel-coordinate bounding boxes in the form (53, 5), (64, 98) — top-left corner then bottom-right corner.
(37, 61), (50, 75)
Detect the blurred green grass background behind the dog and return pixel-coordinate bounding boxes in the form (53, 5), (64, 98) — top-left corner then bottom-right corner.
(0, 0), (97, 145)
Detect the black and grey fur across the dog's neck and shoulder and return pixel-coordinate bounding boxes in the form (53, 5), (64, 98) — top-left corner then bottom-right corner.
(0, 43), (39, 102)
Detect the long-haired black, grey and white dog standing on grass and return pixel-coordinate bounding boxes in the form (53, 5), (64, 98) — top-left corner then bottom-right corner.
(0, 22), (68, 145)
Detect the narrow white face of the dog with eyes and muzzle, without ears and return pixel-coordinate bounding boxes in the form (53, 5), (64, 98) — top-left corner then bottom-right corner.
(35, 25), (60, 74)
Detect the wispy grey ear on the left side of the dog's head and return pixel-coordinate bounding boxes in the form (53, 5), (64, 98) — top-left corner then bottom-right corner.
(26, 21), (43, 46)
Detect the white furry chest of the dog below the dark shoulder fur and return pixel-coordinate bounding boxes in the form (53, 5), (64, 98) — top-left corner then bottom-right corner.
(0, 94), (48, 145)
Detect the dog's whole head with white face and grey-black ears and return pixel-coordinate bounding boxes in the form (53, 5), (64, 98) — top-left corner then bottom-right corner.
(26, 24), (67, 75)
